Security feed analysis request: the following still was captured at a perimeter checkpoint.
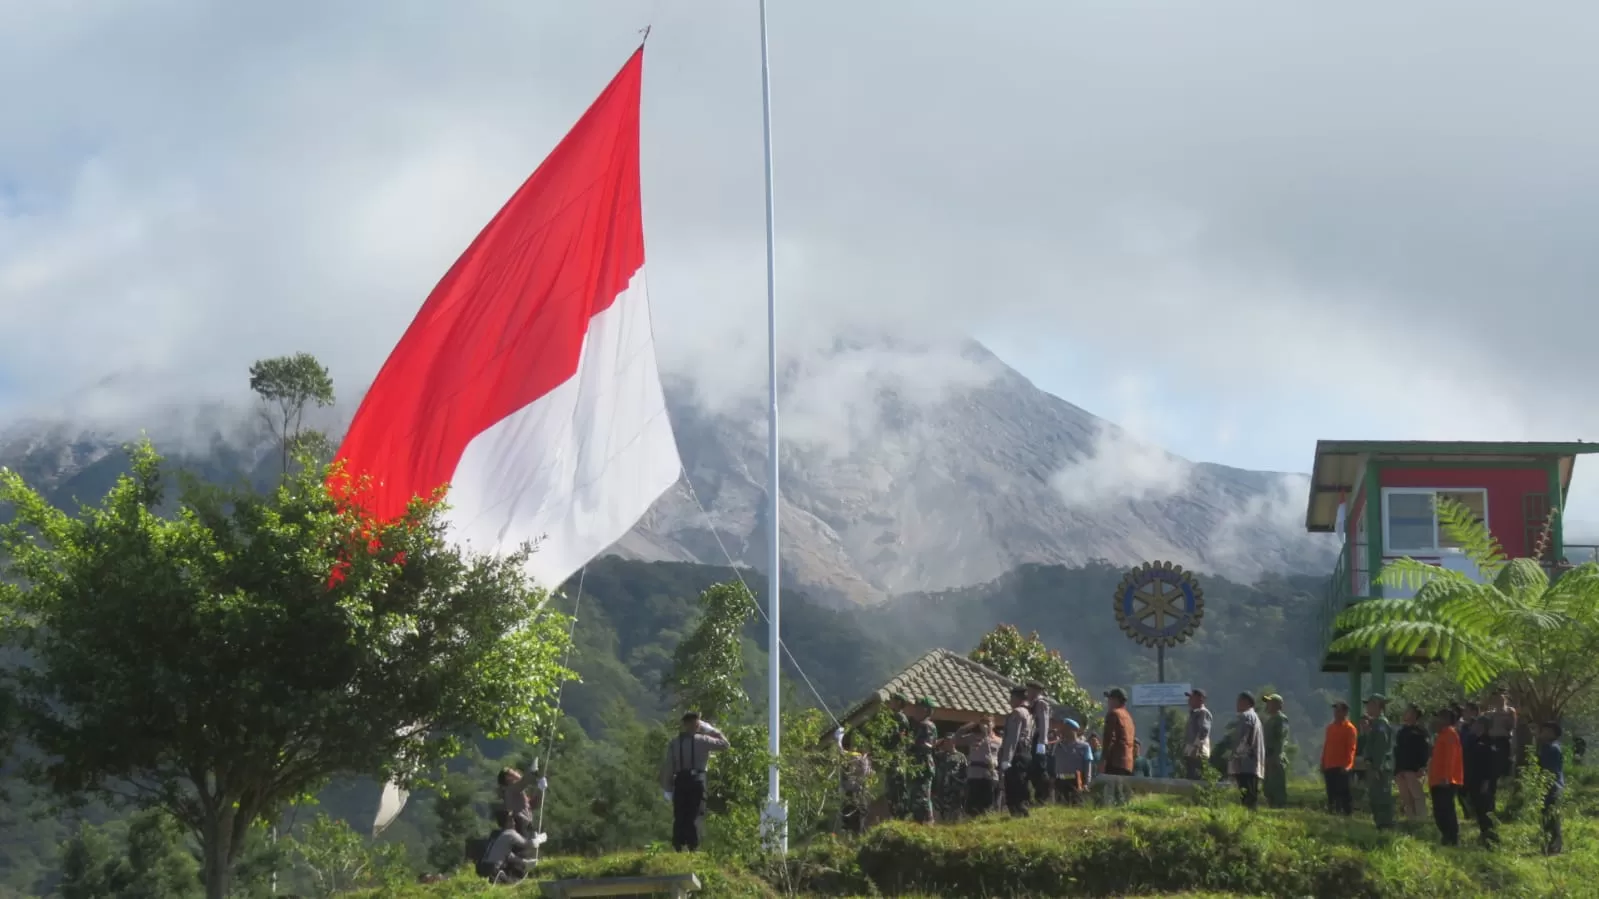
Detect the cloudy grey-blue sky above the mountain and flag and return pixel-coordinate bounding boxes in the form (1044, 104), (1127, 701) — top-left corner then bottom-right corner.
(0, 0), (1599, 518)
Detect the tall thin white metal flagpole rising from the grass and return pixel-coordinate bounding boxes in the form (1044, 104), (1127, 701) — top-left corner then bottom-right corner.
(761, 0), (788, 853)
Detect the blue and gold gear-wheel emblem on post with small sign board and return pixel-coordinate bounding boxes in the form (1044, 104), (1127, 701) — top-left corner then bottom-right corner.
(1116, 561), (1204, 777)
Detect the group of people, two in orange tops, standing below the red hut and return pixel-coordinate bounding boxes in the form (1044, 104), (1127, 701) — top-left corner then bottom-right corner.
(1321, 686), (1567, 854)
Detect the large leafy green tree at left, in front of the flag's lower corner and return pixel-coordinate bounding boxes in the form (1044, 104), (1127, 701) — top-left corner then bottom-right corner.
(0, 443), (566, 899)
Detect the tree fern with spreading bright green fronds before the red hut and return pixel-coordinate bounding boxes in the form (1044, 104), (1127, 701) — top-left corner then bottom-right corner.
(1332, 499), (1599, 721)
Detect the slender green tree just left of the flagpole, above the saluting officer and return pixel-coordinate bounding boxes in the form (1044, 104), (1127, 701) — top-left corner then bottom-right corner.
(668, 581), (755, 721)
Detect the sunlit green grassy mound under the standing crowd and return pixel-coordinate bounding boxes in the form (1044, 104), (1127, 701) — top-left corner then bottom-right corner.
(369, 771), (1599, 899)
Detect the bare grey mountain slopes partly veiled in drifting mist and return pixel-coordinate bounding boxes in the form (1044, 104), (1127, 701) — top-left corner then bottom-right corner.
(0, 338), (1337, 603)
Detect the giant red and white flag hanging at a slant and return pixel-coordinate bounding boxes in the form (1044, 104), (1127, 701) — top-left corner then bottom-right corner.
(337, 48), (681, 589)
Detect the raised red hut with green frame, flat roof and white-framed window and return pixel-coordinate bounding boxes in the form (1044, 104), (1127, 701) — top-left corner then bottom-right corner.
(1305, 440), (1599, 709)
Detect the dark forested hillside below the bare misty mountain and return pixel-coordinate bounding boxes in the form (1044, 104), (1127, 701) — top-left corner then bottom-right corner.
(0, 558), (1324, 896)
